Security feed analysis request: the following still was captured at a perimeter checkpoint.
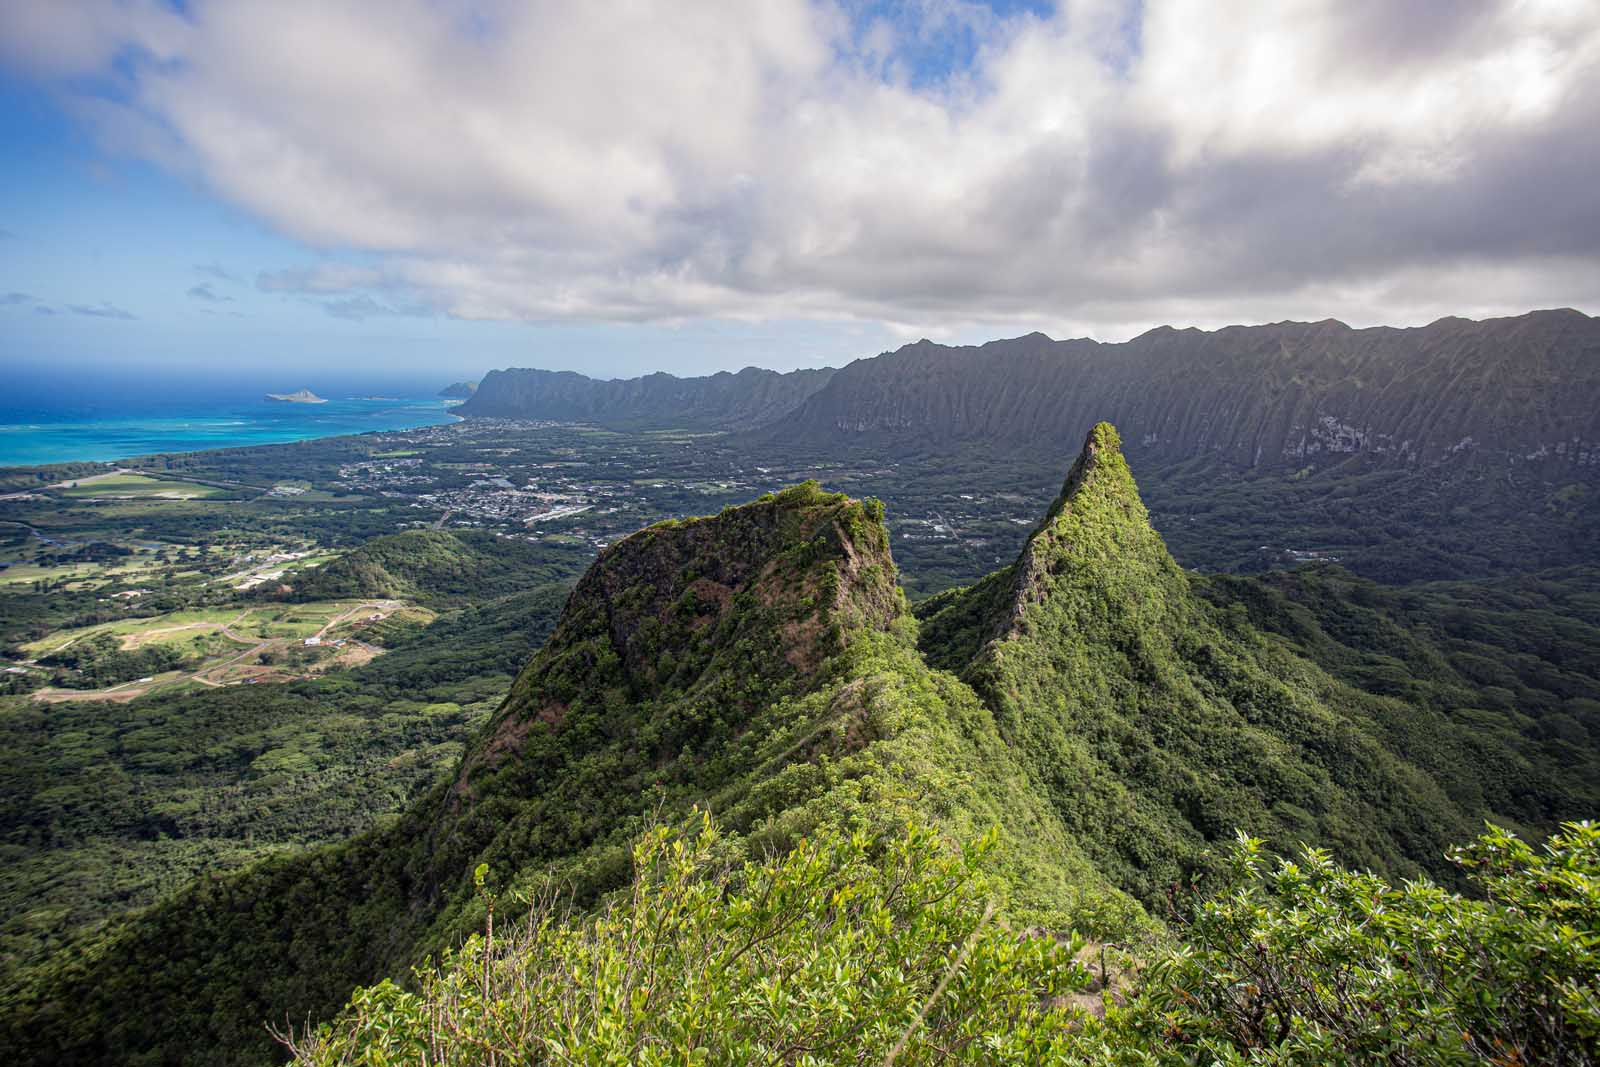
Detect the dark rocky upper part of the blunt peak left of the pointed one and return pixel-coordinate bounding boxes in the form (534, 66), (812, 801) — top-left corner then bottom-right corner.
(470, 482), (902, 761)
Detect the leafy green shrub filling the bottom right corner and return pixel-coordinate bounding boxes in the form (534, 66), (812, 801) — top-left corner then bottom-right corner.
(1120, 824), (1600, 1065)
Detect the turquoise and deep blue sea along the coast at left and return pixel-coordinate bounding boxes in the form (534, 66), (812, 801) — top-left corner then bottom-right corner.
(0, 394), (458, 467)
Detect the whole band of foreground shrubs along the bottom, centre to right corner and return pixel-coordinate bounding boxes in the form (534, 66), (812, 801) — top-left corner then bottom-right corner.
(285, 821), (1600, 1067)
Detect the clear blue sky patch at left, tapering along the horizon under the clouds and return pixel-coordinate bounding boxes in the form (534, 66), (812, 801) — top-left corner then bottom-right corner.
(0, 65), (899, 389)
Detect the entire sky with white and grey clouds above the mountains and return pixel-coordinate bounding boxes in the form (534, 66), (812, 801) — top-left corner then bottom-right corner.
(0, 0), (1600, 384)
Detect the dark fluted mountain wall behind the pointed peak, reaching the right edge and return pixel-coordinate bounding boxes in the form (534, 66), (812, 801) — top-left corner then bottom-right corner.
(762, 310), (1600, 478)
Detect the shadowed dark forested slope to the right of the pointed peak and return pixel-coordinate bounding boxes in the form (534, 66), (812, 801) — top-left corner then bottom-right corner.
(1197, 565), (1600, 832)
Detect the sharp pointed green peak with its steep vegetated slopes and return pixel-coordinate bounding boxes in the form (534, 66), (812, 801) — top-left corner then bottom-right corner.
(922, 424), (1477, 901)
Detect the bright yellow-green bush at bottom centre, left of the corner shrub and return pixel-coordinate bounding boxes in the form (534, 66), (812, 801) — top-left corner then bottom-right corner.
(288, 819), (1088, 1065)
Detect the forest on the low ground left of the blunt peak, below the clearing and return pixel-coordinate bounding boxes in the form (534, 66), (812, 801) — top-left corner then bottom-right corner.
(0, 585), (566, 971)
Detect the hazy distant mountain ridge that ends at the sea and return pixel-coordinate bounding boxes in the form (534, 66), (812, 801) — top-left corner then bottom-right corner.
(454, 366), (834, 430)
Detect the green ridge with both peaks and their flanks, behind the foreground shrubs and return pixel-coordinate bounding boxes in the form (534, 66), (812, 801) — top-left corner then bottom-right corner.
(0, 426), (1592, 1062)
